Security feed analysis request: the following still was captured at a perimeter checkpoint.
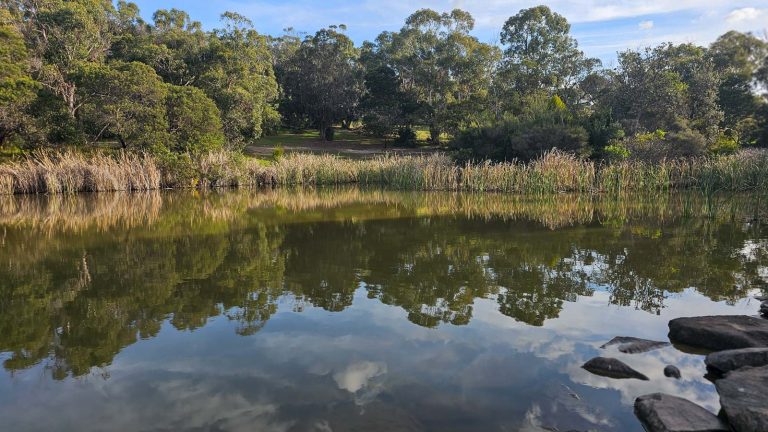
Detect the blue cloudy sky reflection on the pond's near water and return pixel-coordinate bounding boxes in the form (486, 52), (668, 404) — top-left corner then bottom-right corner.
(0, 288), (756, 431)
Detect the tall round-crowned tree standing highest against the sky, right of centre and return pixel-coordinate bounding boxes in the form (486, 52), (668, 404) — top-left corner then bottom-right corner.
(499, 6), (600, 104)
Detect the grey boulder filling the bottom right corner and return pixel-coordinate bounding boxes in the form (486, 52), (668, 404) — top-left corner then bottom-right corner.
(715, 366), (768, 432)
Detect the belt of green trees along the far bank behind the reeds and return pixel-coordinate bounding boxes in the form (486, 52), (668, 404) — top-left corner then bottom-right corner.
(0, 0), (768, 160)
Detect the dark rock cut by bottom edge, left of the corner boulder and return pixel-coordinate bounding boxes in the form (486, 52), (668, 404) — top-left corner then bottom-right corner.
(635, 393), (729, 432)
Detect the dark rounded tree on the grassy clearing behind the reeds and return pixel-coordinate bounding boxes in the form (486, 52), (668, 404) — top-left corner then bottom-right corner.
(280, 26), (362, 139)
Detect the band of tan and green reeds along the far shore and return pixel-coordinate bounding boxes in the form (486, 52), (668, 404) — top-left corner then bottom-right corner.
(0, 151), (768, 194)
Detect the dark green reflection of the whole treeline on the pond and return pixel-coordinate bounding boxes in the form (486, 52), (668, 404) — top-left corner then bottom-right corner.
(0, 192), (768, 378)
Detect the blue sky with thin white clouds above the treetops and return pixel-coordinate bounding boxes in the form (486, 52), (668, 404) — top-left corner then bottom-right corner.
(133, 0), (768, 66)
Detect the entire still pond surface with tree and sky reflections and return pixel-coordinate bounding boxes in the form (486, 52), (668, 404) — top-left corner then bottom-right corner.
(0, 189), (768, 432)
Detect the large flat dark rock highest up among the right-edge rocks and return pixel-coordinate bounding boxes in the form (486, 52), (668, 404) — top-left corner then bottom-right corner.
(669, 315), (768, 351)
